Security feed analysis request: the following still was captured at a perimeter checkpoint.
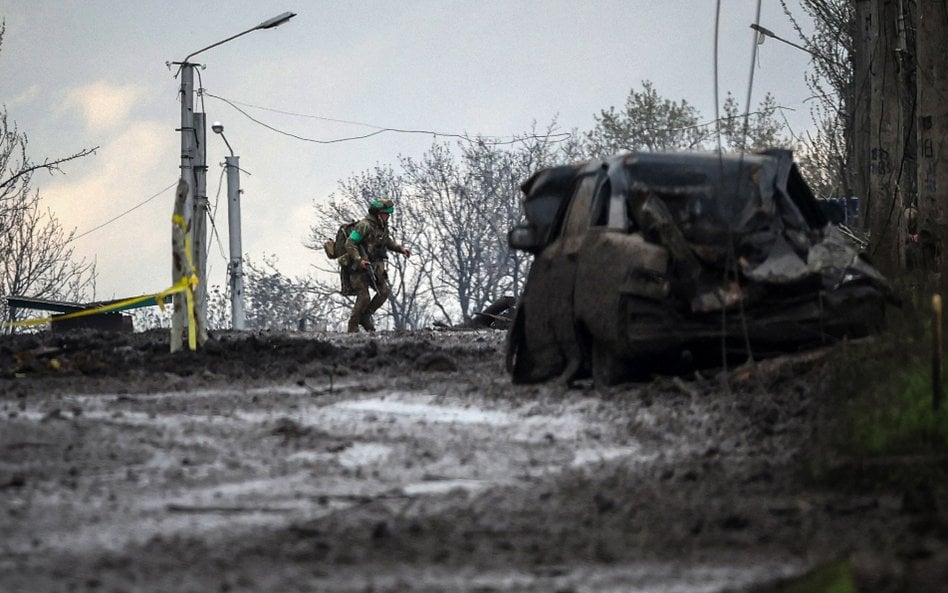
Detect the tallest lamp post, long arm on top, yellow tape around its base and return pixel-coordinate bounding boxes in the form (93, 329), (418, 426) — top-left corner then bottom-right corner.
(171, 12), (296, 352)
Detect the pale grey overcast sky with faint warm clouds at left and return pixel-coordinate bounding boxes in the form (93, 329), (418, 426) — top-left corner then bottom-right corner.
(0, 0), (809, 299)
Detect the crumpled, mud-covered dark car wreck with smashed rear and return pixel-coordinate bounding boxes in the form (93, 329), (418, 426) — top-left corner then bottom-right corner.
(507, 150), (894, 384)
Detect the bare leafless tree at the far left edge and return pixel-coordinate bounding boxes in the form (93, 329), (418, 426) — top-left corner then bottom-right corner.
(0, 24), (98, 328)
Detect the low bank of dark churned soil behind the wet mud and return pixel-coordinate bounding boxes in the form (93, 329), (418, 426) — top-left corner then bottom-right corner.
(0, 330), (503, 391)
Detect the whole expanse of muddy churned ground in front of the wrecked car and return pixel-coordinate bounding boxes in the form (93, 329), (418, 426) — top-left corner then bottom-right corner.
(0, 330), (948, 593)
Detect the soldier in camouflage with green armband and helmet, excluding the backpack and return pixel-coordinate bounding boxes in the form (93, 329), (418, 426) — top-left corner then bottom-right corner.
(346, 200), (411, 333)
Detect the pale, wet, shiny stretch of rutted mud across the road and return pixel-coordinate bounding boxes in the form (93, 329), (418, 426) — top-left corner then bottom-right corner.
(3, 385), (660, 554)
